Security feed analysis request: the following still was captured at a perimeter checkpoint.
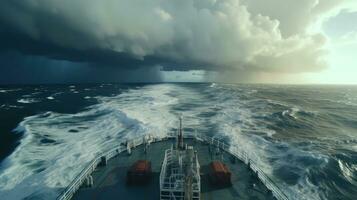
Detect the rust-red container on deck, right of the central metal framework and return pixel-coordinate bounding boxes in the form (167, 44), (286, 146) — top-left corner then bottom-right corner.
(209, 161), (232, 186)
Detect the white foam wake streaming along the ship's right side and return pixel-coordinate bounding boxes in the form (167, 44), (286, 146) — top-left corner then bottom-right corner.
(207, 85), (327, 200)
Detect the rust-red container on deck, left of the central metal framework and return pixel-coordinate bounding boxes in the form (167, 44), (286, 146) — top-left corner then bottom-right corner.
(126, 160), (152, 185)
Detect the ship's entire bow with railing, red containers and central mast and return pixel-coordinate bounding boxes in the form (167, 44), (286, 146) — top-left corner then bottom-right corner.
(57, 118), (288, 200)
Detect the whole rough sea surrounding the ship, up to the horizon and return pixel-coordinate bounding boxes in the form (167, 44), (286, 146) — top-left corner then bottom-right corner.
(0, 83), (357, 200)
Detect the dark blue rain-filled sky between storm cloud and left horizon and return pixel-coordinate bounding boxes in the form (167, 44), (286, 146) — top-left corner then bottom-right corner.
(0, 52), (161, 84)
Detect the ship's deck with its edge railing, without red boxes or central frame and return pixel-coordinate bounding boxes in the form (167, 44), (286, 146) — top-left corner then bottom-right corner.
(57, 135), (288, 200)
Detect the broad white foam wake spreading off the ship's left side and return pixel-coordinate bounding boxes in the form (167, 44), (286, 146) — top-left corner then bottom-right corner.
(0, 85), (177, 200)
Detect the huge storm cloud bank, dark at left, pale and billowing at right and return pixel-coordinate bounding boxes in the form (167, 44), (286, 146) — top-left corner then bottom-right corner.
(0, 0), (347, 77)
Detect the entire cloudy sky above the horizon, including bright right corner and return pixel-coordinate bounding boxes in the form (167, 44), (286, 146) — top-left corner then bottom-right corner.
(0, 0), (357, 84)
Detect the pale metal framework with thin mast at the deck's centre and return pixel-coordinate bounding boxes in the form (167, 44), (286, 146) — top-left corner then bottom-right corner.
(160, 118), (201, 200)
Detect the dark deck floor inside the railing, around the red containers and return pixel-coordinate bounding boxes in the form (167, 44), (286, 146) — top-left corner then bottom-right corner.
(72, 139), (274, 200)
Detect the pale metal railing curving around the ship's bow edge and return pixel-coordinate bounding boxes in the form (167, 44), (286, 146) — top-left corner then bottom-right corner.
(57, 135), (288, 200)
